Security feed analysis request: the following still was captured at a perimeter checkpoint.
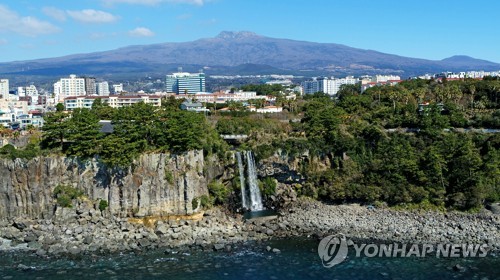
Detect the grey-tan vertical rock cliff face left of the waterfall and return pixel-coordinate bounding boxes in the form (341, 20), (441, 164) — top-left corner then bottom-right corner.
(0, 151), (208, 219)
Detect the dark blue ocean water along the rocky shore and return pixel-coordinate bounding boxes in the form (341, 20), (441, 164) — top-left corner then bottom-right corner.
(0, 238), (500, 280)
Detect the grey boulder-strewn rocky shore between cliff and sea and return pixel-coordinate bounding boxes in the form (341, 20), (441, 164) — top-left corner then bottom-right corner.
(0, 199), (500, 256)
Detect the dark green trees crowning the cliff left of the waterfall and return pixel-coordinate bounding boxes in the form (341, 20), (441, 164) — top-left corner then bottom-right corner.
(42, 99), (227, 166)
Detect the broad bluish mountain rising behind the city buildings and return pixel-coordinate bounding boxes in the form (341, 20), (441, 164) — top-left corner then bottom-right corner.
(0, 31), (500, 77)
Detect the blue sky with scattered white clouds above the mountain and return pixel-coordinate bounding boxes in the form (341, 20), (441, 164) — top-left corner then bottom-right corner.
(0, 0), (500, 63)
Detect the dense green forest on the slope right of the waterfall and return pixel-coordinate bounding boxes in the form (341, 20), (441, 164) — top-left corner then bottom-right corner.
(225, 80), (500, 210)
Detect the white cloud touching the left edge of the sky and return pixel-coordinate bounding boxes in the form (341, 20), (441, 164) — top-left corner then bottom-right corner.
(0, 5), (60, 37)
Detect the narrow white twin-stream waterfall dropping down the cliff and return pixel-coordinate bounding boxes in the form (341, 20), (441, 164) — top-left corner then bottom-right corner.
(236, 151), (264, 211)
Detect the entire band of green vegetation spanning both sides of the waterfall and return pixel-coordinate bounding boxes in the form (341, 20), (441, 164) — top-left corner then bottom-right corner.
(0, 79), (500, 211)
